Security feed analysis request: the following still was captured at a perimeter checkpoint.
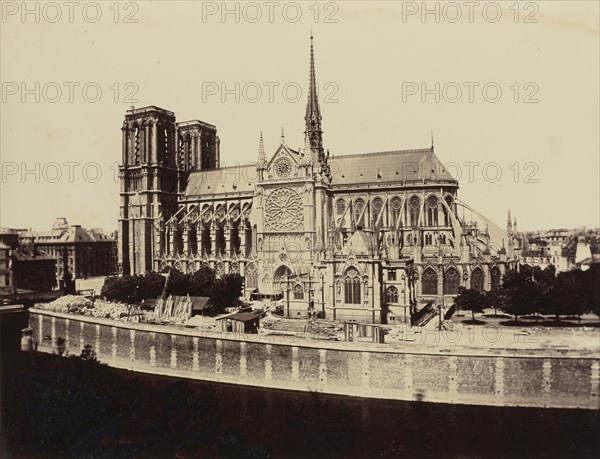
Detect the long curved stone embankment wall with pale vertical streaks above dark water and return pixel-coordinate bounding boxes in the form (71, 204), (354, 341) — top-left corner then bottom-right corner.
(30, 309), (600, 409)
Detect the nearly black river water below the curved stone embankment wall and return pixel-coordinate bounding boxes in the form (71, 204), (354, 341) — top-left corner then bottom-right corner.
(2, 354), (600, 458)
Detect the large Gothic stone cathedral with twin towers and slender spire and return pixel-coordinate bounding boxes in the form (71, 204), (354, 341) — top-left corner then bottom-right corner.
(119, 37), (518, 323)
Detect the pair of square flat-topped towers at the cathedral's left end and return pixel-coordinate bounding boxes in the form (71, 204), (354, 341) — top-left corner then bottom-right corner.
(119, 106), (220, 275)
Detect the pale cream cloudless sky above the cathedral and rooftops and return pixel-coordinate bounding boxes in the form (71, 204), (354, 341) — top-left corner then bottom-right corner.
(0, 1), (600, 231)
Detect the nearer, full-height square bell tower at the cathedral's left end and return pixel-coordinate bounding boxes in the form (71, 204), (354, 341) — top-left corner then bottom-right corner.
(119, 106), (180, 275)
